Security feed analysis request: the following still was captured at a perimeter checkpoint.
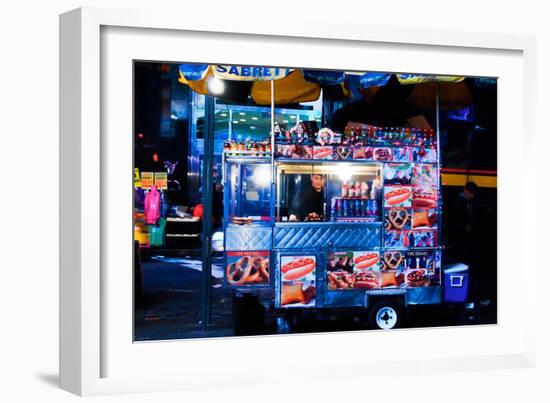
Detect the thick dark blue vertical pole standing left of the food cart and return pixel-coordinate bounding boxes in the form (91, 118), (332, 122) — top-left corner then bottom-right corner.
(201, 95), (215, 331)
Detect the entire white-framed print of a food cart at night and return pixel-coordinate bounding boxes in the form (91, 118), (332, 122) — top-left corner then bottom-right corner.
(60, 9), (536, 394)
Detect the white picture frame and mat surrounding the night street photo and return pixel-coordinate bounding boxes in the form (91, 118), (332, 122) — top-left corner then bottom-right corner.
(60, 8), (536, 395)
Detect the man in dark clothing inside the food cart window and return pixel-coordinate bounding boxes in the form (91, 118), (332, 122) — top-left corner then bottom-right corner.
(288, 175), (325, 221)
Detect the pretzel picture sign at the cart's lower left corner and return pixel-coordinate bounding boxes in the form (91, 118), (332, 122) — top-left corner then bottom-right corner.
(224, 251), (269, 287)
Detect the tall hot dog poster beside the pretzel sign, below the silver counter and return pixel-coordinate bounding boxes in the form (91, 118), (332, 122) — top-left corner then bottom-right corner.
(281, 256), (316, 307)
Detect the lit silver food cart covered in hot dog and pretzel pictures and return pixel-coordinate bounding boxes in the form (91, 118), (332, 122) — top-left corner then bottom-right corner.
(223, 122), (443, 332)
